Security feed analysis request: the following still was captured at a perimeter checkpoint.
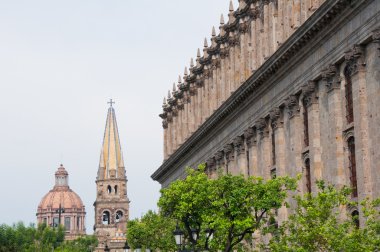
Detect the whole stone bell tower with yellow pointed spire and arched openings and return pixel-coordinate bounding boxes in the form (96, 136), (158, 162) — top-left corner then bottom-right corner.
(94, 99), (129, 251)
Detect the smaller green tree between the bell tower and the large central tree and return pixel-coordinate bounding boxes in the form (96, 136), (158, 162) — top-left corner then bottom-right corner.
(127, 211), (176, 251)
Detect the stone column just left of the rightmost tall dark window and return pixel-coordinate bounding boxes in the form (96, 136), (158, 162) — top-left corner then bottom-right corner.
(322, 65), (347, 187)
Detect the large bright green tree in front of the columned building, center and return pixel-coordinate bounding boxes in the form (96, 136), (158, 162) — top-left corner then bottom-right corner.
(158, 166), (296, 251)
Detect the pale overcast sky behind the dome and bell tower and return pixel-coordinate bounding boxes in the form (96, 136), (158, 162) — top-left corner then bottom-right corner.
(0, 0), (237, 233)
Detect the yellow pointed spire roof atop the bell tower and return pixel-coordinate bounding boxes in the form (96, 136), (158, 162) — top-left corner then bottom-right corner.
(99, 100), (124, 179)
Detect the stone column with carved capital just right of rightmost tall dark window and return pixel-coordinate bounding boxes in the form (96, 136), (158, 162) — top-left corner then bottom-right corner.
(345, 45), (374, 201)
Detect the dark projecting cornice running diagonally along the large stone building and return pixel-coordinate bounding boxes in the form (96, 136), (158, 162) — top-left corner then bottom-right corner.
(151, 0), (362, 182)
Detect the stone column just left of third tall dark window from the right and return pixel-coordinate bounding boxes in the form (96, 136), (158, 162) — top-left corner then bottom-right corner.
(256, 118), (272, 179)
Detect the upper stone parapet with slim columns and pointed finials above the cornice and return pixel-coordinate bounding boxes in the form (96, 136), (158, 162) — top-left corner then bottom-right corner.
(160, 0), (323, 159)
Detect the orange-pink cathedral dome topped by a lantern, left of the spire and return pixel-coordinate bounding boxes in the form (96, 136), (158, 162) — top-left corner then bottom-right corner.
(36, 165), (86, 239)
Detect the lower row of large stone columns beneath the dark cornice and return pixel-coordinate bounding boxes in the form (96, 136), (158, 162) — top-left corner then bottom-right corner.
(206, 39), (380, 208)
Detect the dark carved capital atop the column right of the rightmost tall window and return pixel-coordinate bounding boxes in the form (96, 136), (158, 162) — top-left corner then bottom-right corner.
(344, 45), (366, 76)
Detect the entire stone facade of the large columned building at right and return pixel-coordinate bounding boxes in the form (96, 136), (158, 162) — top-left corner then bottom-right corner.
(152, 0), (380, 223)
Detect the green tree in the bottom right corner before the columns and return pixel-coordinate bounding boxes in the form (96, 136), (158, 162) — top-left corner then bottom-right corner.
(268, 181), (380, 252)
